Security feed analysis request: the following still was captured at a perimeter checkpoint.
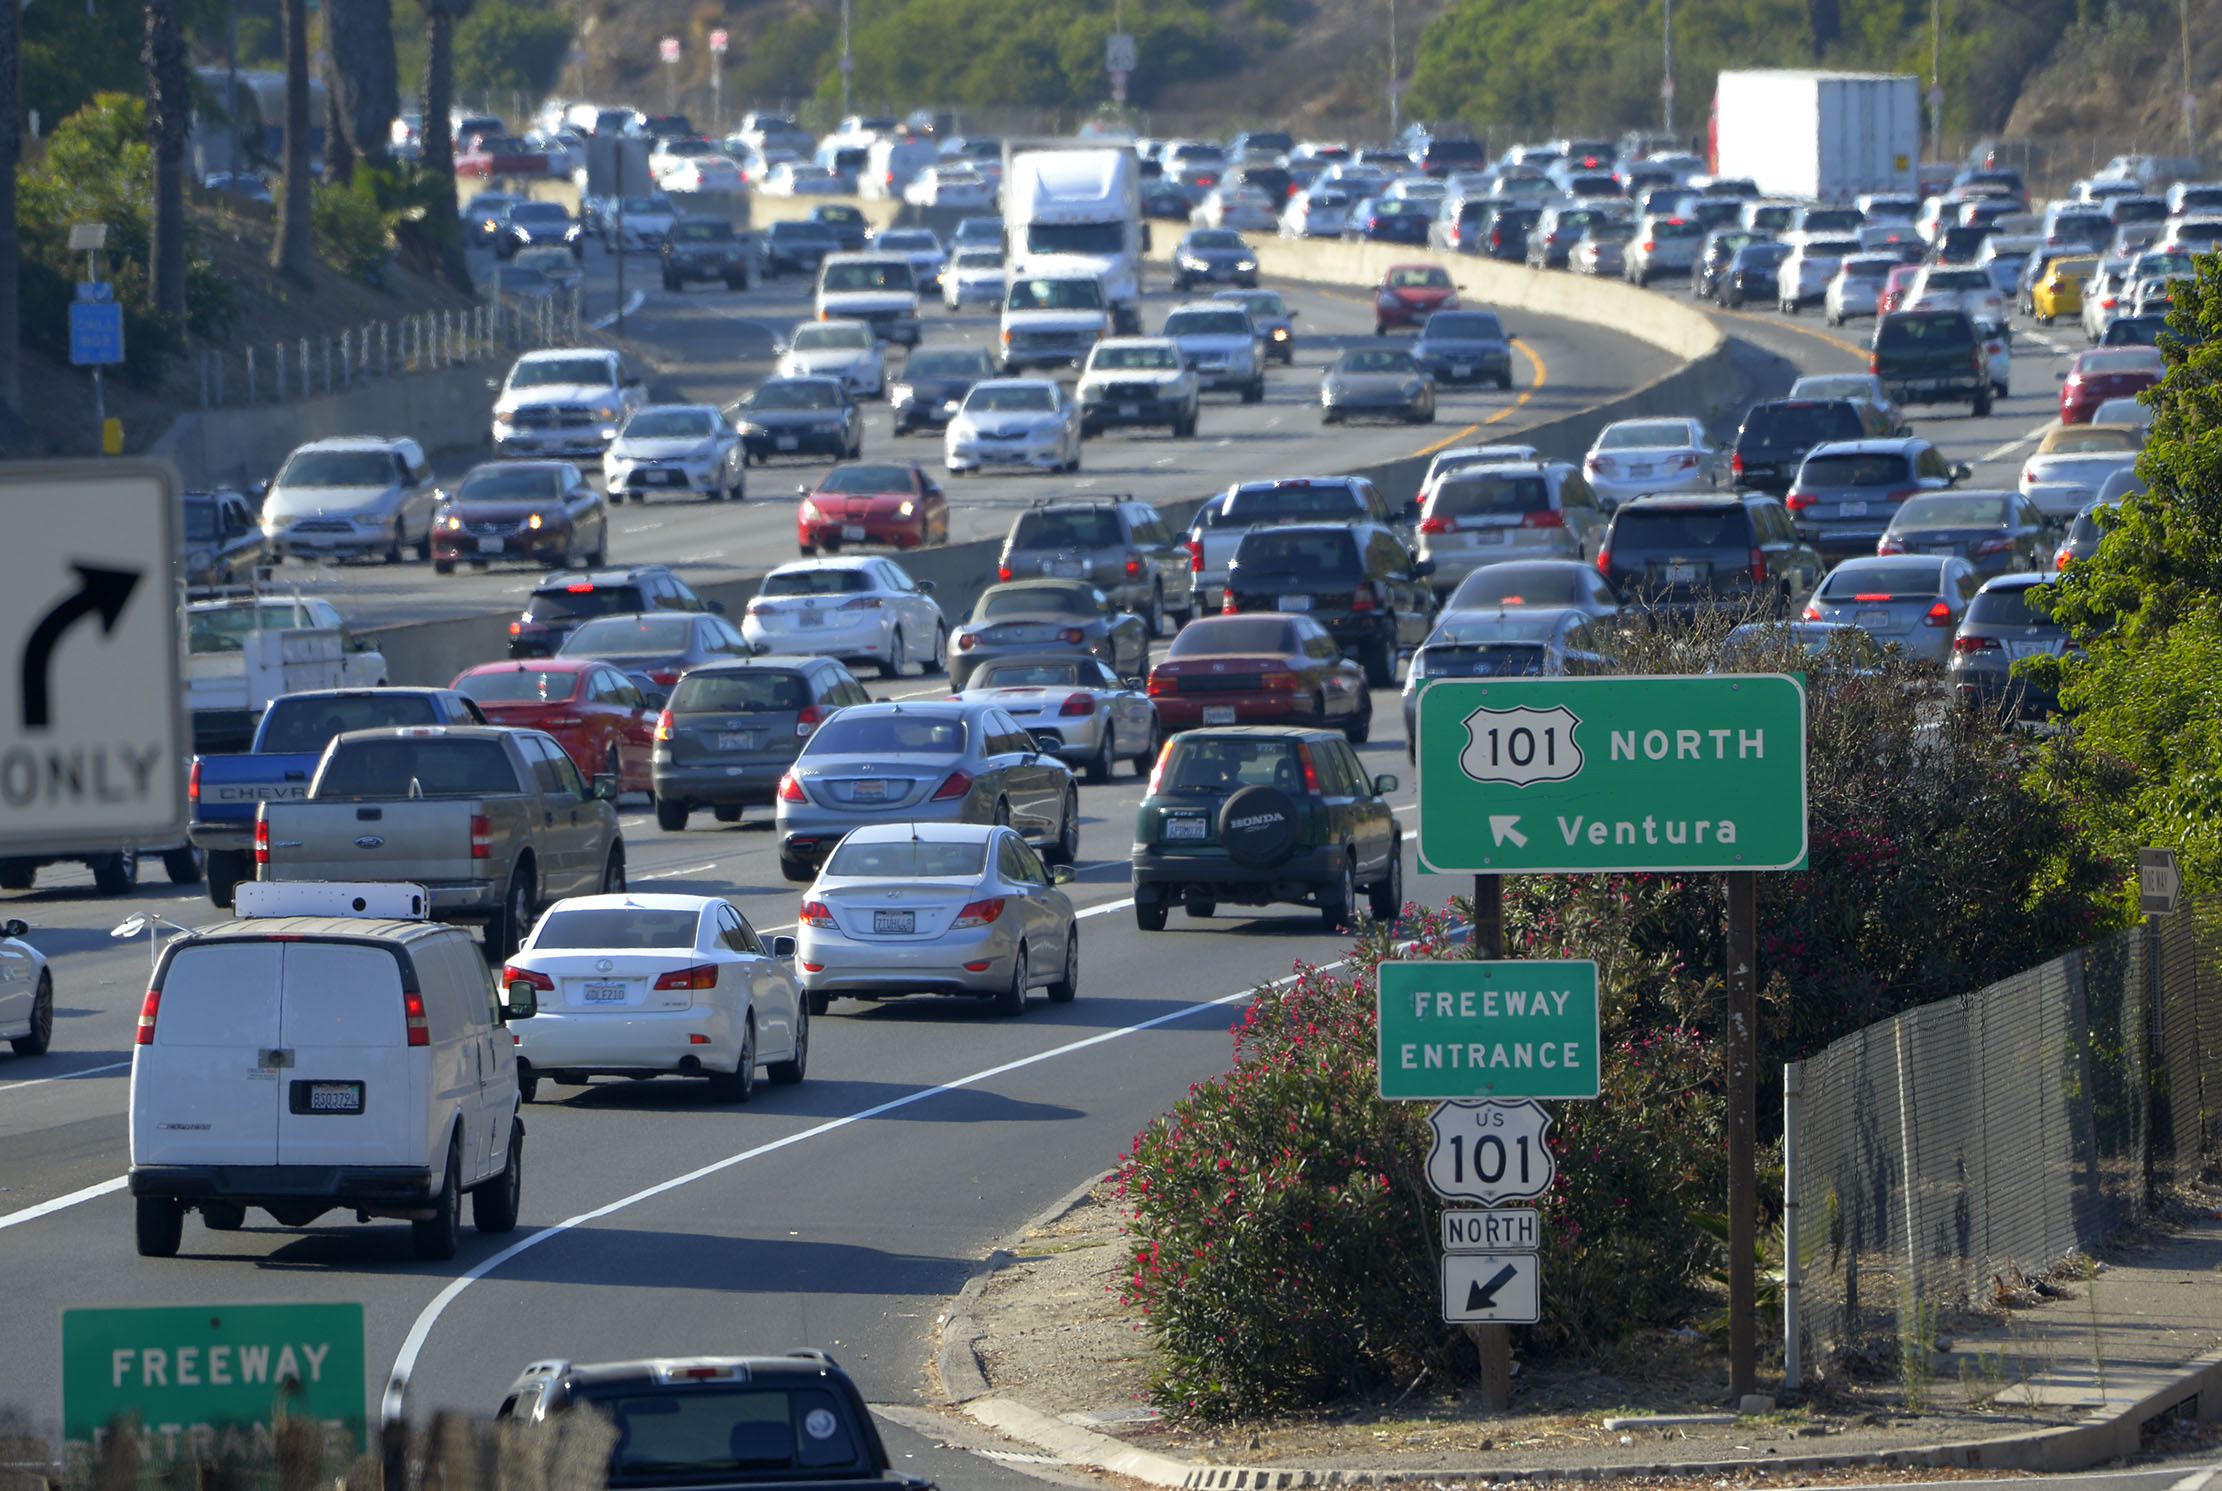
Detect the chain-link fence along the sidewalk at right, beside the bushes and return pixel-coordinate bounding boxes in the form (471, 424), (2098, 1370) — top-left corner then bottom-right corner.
(1786, 898), (2222, 1369)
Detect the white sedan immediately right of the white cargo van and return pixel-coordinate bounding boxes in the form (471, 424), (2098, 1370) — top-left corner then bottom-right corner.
(502, 891), (811, 1102)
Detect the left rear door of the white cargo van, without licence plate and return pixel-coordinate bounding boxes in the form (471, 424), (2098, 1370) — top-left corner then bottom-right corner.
(131, 938), (289, 1164)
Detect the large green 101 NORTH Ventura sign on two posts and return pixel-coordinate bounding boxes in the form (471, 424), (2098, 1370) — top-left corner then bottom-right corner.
(1415, 673), (1806, 875)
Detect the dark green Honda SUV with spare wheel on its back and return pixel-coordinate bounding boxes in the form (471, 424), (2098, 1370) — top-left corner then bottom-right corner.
(1133, 724), (1404, 931)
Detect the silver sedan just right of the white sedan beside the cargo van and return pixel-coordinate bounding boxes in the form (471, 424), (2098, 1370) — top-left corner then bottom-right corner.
(795, 822), (1080, 1015)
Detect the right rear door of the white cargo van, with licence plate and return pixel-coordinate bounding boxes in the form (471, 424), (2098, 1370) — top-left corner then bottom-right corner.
(278, 942), (429, 1164)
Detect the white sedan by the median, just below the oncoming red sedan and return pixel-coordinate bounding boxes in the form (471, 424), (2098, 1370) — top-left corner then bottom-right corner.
(740, 556), (949, 678)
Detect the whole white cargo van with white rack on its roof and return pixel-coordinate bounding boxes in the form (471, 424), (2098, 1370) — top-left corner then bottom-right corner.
(131, 880), (533, 1258)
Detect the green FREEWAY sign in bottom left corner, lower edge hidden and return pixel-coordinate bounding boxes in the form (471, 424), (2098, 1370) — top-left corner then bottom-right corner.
(62, 1304), (369, 1453)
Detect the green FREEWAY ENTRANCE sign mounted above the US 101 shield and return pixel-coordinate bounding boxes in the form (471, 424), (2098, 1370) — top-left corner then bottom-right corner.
(1373, 958), (1598, 1102)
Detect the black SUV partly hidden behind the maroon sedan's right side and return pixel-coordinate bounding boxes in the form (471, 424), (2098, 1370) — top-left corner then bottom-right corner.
(1222, 522), (1435, 689)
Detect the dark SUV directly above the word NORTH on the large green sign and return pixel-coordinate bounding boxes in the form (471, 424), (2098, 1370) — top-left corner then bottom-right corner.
(1598, 491), (1826, 618)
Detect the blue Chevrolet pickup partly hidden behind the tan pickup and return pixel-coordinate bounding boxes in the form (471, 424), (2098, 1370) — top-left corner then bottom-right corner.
(187, 689), (487, 907)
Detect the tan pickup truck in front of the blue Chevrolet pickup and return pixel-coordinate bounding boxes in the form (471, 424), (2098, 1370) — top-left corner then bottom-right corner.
(256, 724), (624, 958)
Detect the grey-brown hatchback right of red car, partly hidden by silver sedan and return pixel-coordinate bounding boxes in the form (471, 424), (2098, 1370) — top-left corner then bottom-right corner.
(653, 653), (871, 833)
